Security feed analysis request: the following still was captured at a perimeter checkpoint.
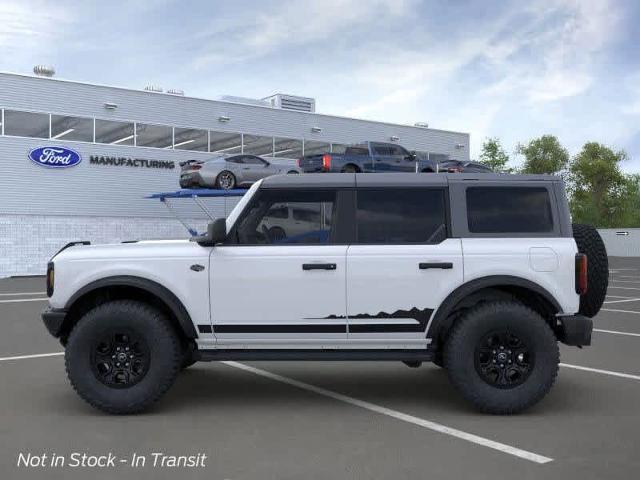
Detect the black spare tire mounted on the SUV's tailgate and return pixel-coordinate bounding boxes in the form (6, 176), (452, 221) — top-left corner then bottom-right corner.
(572, 223), (609, 317)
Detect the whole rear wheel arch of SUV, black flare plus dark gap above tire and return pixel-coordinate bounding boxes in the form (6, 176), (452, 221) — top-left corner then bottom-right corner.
(426, 275), (562, 348)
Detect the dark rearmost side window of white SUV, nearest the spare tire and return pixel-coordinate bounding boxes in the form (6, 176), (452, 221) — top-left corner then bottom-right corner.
(467, 187), (553, 233)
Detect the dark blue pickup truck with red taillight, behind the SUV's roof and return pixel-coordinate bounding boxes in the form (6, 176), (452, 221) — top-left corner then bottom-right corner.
(298, 142), (438, 173)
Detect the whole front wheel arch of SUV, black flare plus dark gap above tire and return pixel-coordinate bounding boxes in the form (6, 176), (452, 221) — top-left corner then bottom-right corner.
(61, 275), (198, 341)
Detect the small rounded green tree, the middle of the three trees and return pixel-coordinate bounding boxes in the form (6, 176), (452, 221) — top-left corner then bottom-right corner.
(516, 135), (569, 174)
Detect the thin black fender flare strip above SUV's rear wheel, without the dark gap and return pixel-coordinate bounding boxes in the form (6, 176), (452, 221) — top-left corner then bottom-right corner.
(426, 275), (562, 338)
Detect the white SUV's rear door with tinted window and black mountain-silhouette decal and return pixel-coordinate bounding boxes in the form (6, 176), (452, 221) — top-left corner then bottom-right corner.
(347, 186), (463, 348)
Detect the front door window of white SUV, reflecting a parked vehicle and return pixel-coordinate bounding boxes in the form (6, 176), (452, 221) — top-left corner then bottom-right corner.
(232, 190), (336, 245)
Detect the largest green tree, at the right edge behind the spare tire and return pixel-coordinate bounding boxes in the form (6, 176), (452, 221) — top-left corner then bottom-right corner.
(569, 142), (640, 227)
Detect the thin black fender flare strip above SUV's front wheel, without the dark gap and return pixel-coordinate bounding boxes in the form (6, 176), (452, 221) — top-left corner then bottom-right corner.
(65, 275), (198, 339)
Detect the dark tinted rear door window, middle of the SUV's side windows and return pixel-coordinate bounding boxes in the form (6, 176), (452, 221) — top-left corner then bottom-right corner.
(356, 188), (447, 244)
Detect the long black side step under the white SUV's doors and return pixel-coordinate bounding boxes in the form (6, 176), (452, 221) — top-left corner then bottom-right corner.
(196, 349), (434, 362)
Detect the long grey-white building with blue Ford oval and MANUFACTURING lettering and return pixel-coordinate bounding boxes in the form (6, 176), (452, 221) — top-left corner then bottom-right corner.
(0, 69), (469, 277)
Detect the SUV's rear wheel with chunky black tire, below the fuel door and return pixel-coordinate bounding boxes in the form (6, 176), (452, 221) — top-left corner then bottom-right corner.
(443, 301), (560, 414)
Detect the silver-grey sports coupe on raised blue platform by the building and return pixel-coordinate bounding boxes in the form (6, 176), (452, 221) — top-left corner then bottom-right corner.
(180, 154), (300, 190)
